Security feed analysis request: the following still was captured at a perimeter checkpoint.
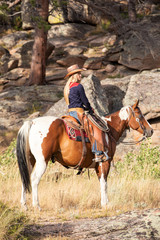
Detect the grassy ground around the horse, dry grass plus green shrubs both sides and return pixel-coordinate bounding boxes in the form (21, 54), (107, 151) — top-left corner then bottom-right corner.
(0, 139), (160, 239)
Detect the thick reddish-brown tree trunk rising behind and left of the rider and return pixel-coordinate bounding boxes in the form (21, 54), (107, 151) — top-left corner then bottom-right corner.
(27, 0), (49, 85)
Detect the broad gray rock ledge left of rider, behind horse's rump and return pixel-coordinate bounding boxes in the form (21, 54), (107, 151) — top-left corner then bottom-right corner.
(0, 85), (63, 131)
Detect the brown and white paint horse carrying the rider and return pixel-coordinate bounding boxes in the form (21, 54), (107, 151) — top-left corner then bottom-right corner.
(16, 101), (153, 209)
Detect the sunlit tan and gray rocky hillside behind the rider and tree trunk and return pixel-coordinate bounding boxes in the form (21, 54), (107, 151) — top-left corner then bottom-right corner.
(0, 24), (160, 154)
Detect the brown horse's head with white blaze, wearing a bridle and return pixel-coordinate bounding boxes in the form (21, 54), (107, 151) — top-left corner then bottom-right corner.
(128, 100), (153, 137)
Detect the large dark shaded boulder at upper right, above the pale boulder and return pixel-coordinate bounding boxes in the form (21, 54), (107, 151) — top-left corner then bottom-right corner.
(106, 15), (160, 70)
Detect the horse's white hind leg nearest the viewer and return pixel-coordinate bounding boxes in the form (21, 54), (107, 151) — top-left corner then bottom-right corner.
(31, 156), (47, 210)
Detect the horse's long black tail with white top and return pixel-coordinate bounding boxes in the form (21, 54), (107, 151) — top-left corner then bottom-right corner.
(16, 121), (32, 192)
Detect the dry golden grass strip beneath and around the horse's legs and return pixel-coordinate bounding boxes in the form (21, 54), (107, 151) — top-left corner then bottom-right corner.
(0, 158), (160, 221)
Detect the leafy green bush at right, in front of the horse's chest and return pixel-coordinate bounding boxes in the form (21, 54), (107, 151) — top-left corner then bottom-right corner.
(116, 141), (160, 178)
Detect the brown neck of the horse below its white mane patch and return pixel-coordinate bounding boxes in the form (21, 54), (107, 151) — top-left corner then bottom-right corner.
(107, 112), (127, 142)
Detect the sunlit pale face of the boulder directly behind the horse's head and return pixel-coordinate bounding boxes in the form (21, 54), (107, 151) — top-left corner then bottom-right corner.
(123, 69), (160, 119)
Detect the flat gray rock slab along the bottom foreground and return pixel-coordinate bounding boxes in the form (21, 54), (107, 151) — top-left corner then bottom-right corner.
(25, 209), (160, 240)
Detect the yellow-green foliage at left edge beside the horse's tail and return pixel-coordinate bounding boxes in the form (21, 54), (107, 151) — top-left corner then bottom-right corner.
(0, 139), (16, 165)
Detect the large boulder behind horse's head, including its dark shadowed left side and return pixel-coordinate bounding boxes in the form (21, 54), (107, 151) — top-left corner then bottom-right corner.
(101, 69), (160, 119)
